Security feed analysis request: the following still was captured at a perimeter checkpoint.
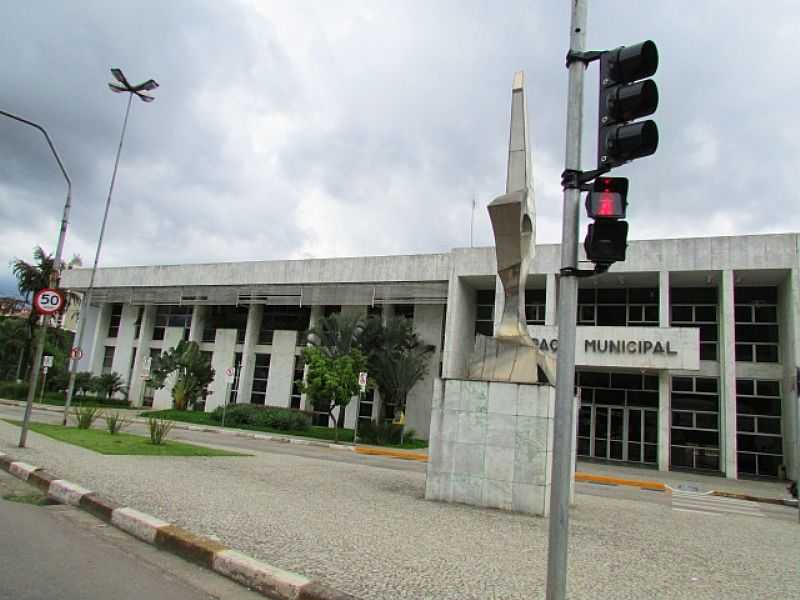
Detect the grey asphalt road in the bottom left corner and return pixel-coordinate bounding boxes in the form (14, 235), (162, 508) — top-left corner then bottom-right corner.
(0, 471), (263, 600)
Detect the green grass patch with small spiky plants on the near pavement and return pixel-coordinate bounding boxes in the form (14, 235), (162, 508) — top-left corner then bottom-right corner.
(7, 420), (249, 456)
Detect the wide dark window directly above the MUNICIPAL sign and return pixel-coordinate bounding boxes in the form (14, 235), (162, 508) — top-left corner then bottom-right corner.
(578, 288), (658, 327)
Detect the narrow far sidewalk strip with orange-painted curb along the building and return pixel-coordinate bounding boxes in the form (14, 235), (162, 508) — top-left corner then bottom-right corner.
(0, 399), (797, 506)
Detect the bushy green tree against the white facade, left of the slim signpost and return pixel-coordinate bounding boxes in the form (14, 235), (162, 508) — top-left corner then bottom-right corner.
(150, 340), (214, 410)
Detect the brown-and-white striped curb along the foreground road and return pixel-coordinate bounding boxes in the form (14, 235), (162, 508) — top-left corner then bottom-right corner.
(0, 452), (358, 600)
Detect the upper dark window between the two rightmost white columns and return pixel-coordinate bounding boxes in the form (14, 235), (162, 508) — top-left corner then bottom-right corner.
(733, 287), (779, 363)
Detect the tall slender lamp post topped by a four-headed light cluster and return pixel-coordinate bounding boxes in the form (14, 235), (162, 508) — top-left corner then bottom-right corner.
(62, 69), (158, 425)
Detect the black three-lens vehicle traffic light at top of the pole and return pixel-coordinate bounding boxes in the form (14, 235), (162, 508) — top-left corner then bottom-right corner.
(597, 40), (658, 169)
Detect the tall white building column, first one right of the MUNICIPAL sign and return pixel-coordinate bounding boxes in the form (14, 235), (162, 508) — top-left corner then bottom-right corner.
(719, 270), (738, 479)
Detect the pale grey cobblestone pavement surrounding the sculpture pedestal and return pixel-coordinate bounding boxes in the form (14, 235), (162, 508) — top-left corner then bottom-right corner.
(0, 422), (800, 600)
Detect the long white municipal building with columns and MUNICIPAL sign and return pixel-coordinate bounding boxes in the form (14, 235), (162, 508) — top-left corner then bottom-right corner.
(63, 234), (800, 478)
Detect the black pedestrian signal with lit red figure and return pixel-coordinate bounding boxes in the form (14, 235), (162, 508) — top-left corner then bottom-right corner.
(583, 177), (628, 270)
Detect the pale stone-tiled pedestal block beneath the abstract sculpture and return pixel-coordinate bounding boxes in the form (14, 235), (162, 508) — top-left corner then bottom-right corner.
(425, 379), (574, 516)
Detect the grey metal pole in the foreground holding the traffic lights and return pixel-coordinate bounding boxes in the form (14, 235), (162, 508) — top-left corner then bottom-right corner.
(546, 0), (587, 600)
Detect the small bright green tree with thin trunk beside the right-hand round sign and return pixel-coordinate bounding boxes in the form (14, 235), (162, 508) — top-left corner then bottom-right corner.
(298, 346), (366, 441)
